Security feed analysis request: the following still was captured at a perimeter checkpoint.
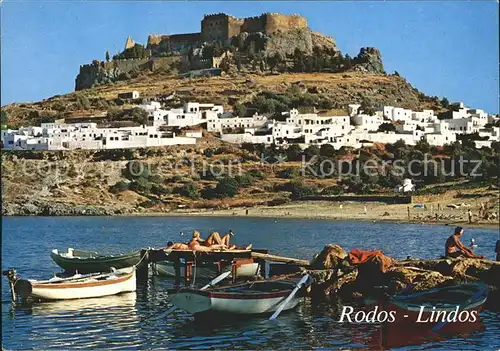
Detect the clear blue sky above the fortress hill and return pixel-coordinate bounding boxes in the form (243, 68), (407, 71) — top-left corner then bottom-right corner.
(0, 0), (499, 113)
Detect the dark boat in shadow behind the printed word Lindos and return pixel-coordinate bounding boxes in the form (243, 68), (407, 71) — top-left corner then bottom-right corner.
(382, 283), (488, 325)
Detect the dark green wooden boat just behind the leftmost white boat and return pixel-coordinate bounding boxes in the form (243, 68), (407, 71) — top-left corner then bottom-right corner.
(50, 248), (141, 274)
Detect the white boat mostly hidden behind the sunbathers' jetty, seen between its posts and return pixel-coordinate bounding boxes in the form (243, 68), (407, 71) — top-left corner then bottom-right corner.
(156, 261), (260, 279)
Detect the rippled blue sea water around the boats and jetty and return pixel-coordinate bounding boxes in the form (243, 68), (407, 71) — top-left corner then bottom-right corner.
(2, 217), (500, 350)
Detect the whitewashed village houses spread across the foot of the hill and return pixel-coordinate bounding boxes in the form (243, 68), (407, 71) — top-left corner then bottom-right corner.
(1, 91), (500, 150)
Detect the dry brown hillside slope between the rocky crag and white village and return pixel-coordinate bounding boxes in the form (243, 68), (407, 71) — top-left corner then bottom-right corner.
(4, 70), (442, 127)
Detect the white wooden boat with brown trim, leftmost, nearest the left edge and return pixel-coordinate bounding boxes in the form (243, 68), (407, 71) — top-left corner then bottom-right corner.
(13, 269), (136, 300)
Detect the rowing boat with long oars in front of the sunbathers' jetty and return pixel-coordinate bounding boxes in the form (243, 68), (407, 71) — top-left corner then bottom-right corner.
(171, 280), (302, 318)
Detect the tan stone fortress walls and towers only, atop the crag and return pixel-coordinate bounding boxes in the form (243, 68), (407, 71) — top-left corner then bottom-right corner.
(144, 13), (307, 53)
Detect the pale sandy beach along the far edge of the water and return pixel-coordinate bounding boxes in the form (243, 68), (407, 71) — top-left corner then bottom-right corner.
(130, 201), (499, 229)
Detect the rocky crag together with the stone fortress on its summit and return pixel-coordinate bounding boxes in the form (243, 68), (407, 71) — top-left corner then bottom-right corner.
(75, 13), (384, 90)
